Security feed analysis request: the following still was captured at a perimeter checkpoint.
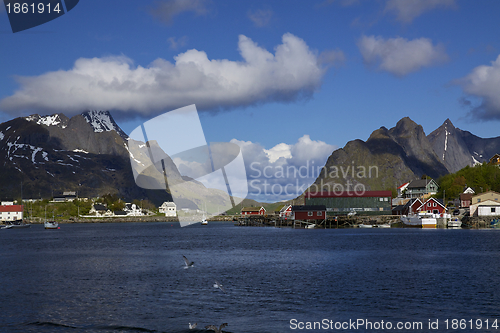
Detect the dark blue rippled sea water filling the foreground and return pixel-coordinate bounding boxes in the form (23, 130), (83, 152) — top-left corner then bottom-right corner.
(0, 223), (500, 333)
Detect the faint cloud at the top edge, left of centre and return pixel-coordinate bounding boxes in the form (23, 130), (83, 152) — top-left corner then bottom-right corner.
(149, 0), (209, 24)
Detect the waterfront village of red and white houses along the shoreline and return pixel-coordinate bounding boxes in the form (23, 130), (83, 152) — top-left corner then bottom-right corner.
(0, 154), (500, 228)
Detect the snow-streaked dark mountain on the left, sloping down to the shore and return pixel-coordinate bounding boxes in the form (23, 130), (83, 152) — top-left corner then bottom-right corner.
(0, 111), (240, 209)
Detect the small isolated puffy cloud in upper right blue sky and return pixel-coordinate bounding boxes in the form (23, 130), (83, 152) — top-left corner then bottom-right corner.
(358, 36), (448, 76)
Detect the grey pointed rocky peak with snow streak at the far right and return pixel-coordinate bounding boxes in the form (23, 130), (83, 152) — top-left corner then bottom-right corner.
(428, 119), (500, 172)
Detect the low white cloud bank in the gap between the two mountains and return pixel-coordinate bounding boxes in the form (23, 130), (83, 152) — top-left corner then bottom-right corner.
(231, 135), (337, 202)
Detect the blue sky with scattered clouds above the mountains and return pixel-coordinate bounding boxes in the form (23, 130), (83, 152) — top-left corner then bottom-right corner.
(0, 0), (500, 200)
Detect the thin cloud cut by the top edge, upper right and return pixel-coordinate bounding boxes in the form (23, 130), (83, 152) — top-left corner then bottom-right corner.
(385, 0), (456, 23)
